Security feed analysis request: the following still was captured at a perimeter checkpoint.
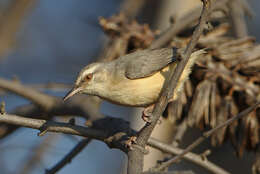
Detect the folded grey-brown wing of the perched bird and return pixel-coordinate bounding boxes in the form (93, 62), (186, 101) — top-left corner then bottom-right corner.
(125, 48), (177, 79)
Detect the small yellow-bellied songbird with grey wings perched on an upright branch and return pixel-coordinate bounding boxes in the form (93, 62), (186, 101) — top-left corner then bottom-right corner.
(64, 48), (205, 120)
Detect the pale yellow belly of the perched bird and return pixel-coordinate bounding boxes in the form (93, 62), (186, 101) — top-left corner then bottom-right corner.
(105, 65), (175, 106)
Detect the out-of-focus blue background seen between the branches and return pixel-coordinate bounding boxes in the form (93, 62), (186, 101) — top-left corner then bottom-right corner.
(0, 0), (260, 174)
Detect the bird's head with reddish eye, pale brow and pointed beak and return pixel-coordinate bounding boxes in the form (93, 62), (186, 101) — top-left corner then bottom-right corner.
(63, 63), (106, 101)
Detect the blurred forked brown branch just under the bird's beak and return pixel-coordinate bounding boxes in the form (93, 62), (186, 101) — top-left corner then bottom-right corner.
(0, 78), (104, 138)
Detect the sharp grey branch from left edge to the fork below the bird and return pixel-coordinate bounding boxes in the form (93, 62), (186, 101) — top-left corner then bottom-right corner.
(0, 114), (136, 152)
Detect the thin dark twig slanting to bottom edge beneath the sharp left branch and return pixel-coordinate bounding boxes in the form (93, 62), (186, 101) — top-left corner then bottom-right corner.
(45, 138), (91, 174)
